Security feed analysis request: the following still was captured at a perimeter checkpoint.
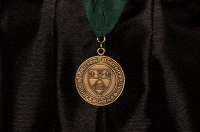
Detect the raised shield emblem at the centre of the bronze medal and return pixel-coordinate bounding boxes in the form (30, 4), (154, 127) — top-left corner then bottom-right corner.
(88, 69), (112, 96)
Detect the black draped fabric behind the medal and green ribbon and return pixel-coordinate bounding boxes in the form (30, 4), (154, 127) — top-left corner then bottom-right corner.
(0, 0), (200, 132)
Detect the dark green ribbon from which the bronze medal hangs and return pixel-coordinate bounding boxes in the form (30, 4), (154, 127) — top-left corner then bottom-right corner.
(82, 0), (127, 37)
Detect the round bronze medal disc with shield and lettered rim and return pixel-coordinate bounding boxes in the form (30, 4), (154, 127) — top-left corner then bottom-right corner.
(75, 56), (125, 106)
